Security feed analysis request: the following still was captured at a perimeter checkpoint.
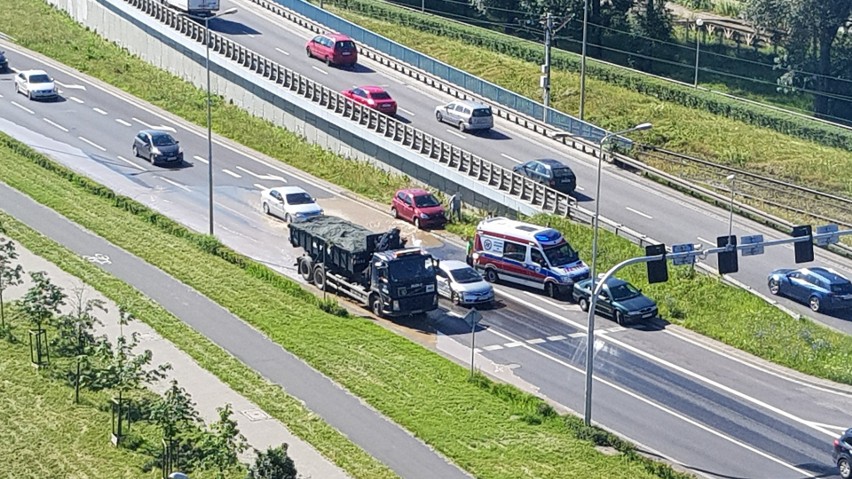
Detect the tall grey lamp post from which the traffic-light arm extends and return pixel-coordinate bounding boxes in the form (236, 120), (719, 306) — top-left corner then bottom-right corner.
(583, 123), (652, 426)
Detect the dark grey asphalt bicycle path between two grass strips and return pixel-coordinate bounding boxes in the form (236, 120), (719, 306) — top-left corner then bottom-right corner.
(0, 183), (470, 479)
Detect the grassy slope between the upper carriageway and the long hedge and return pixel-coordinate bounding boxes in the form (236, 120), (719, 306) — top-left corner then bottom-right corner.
(326, 6), (852, 196)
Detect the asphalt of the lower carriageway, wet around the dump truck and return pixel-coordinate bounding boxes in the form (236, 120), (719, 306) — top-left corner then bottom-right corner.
(0, 45), (852, 478)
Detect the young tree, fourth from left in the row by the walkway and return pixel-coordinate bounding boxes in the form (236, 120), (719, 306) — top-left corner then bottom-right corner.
(92, 308), (170, 444)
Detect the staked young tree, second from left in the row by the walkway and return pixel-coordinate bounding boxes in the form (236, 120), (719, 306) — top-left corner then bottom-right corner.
(21, 271), (66, 366)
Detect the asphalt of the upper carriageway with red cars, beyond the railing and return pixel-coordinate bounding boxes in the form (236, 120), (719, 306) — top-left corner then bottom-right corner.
(205, 0), (852, 334)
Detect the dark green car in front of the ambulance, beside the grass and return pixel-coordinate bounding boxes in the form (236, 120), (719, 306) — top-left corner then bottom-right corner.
(573, 278), (658, 326)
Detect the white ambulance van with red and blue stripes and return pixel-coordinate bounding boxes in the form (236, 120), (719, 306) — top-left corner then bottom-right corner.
(470, 217), (589, 298)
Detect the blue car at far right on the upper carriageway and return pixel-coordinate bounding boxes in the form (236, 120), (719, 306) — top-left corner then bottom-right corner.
(769, 268), (852, 312)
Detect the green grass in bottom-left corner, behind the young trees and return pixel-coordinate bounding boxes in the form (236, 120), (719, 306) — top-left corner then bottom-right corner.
(0, 314), (160, 479)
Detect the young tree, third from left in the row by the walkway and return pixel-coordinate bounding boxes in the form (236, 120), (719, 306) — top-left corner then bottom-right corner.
(51, 286), (107, 403)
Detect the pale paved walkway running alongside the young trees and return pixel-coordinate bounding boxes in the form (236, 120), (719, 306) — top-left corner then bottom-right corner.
(4, 238), (349, 479)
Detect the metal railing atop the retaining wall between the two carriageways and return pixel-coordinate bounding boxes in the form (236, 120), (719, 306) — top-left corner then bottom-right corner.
(125, 0), (576, 216)
